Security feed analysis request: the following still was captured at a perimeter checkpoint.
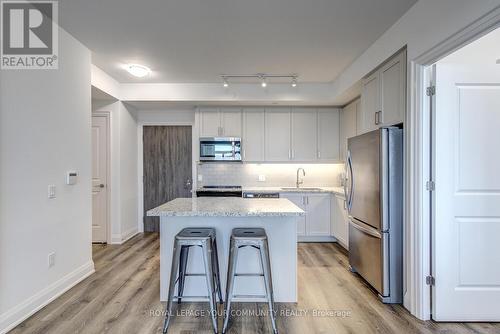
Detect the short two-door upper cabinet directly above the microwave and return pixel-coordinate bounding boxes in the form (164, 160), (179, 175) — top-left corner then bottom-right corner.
(199, 108), (241, 137)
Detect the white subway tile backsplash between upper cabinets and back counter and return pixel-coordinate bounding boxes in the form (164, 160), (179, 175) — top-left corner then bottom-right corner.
(197, 162), (344, 187)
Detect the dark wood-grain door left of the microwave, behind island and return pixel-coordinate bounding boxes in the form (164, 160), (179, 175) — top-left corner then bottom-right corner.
(143, 126), (192, 232)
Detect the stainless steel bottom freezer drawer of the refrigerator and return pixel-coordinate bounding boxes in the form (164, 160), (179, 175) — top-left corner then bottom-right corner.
(349, 220), (389, 296)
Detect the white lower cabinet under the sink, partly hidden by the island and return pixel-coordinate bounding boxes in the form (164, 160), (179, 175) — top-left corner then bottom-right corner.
(280, 193), (333, 242)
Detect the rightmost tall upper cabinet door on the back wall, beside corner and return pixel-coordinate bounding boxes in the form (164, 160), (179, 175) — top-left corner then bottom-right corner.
(318, 109), (340, 161)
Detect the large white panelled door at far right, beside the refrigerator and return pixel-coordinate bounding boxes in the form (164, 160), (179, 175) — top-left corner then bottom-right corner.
(432, 63), (500, 321)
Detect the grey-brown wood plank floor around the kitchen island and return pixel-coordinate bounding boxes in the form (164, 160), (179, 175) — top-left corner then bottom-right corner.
(11, 233), (500, 334)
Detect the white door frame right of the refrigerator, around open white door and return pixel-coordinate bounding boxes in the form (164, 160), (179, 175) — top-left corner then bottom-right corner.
(404, 6), (500, 320)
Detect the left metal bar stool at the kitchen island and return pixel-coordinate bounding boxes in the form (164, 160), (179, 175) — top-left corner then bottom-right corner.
(163, 228), (223, 333)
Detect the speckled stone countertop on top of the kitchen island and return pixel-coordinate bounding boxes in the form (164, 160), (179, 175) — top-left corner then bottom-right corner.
(147, 197), (305, 217)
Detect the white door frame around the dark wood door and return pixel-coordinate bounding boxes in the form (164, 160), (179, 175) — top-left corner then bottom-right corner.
(137, 121), (199, 233)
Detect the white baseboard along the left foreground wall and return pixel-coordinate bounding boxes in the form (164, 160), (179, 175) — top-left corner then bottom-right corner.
(0, 260), (95, 334)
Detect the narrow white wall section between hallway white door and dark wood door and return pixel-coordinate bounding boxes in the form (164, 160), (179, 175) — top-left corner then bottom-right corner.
(93, 101), (138, 244)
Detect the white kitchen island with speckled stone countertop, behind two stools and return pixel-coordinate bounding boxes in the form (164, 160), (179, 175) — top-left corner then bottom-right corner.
(147, 197), (305, 302)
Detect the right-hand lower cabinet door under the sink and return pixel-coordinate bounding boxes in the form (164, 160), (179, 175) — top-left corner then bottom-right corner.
(306, 194), (330, 236)
